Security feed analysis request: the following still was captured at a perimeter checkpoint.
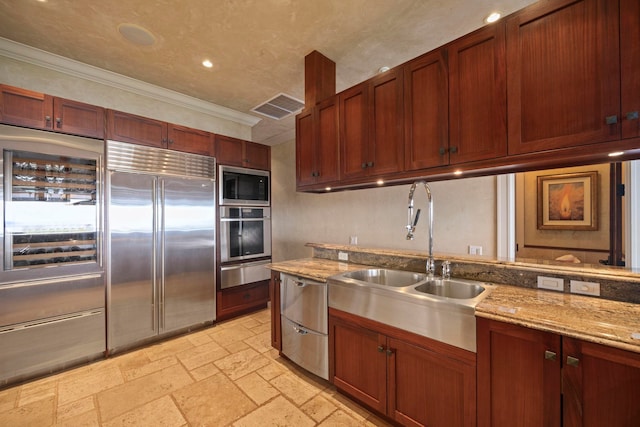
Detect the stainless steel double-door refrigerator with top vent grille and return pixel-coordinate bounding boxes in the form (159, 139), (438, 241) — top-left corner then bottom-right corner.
(107, 141), (216, 352)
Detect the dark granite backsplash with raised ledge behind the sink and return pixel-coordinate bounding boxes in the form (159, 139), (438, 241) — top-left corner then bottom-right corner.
(306, 243), (640, 304)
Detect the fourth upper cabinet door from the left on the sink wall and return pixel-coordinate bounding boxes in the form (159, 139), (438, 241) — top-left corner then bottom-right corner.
(366, 68), (404, 175)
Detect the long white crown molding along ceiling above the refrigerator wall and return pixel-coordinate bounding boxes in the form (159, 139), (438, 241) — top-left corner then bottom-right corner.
(0, 37), (261, 126)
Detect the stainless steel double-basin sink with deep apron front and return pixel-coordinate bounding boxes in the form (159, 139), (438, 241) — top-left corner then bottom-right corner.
(327, 268), (493, 352)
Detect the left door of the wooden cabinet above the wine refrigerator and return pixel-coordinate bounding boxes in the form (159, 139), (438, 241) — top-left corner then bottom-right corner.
(0, 85), (53, 130)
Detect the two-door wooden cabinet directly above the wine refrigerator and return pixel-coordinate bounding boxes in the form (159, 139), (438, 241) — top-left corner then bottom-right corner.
(0, 85), (104, 139)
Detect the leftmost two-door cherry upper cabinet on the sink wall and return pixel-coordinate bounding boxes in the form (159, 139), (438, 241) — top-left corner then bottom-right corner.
(296, 97), (340, 187)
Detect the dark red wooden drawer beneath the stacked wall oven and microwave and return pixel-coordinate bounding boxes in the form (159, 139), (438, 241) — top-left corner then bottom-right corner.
(216, 280), (269, 320)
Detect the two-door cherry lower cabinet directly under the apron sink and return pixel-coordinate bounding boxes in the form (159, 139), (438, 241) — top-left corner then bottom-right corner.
(329, 309), (476, 426)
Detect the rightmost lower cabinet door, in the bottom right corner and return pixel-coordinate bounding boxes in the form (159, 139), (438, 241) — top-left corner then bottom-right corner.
(562, 337), (640, 427)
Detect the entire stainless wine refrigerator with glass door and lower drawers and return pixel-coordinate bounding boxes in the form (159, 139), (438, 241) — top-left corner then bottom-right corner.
(0, 125), (106, 385)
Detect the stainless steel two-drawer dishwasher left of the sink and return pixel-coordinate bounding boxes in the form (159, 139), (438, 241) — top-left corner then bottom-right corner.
(280, 274), (329, 380)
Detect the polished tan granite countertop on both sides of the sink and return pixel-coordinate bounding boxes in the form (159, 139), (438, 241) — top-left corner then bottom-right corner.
(268, 258), (640, 353)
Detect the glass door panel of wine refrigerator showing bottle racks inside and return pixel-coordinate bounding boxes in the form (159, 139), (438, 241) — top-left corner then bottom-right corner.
(4, 150), (99, 270)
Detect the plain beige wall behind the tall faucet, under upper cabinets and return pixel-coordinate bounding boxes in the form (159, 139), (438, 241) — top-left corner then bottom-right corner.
(271, 141), (496, 261)
